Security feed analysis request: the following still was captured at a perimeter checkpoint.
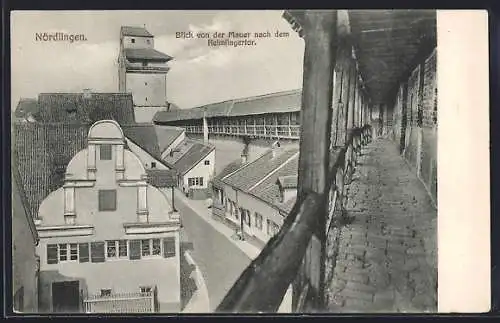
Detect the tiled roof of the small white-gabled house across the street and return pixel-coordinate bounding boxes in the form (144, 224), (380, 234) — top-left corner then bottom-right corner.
(163, 139), (215, 175)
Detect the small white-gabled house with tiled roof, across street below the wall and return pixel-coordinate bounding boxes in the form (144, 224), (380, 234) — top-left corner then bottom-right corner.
(163, 138), (215, 199)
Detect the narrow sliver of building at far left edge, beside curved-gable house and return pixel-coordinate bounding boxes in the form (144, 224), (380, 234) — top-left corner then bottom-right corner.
(12, 160), (40, 313)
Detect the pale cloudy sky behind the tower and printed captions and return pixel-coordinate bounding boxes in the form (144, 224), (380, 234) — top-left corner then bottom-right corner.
(11, 10), (304, 109)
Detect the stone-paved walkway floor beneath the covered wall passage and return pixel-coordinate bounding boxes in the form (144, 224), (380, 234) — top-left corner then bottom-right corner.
(327, 139), (437, 313)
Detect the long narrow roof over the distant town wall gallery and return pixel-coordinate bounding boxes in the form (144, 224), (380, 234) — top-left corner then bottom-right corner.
(153, 90), (302, 123)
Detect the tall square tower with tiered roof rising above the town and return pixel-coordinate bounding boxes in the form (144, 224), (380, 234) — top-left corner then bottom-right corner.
(118, 26), (172, 122)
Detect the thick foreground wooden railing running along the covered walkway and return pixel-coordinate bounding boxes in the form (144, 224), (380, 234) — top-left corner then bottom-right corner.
(216, 125), (372, 313)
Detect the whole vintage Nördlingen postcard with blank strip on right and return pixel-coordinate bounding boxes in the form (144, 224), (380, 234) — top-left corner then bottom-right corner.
(11, 9), (491, 315)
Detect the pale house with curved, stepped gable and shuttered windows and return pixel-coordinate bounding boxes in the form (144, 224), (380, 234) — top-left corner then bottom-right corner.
(37, 120), (181, 313)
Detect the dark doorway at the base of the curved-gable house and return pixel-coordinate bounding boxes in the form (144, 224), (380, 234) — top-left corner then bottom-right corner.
(52, 280), (80, 313)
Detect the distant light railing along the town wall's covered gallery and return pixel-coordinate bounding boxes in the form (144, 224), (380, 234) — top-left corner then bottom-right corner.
(183, 124), (300, 139)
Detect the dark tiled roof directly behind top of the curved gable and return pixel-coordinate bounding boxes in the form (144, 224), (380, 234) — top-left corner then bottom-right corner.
(38, 93), (135, 124)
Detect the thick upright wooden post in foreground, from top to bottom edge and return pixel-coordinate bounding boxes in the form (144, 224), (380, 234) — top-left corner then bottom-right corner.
(298, 10), (337, 309)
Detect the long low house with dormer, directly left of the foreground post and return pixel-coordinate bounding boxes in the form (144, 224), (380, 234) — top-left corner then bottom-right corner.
(212, 143), (299, 246)
